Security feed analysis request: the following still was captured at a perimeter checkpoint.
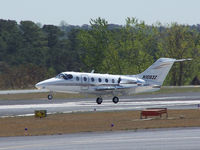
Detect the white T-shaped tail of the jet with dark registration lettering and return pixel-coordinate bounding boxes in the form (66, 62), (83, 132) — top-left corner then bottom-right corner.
(137, 58), (191, 86)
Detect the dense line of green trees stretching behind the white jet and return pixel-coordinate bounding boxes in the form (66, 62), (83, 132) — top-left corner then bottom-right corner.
(0, 18), (200, 89)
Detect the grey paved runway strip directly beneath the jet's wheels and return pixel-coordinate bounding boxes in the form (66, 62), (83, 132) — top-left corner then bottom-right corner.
(0, 92), (200, 117)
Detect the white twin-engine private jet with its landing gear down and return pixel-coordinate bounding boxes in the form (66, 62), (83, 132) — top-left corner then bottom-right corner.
(35, 58), (191, 104)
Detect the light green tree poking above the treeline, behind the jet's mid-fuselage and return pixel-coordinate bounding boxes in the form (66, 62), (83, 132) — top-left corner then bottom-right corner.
(78, 18), (109, 72)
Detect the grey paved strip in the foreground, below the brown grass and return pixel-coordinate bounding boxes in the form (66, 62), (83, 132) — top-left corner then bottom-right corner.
(0, 128), (200, 150)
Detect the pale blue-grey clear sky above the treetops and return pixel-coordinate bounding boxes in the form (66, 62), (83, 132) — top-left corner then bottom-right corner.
(0, 0), (200, 25)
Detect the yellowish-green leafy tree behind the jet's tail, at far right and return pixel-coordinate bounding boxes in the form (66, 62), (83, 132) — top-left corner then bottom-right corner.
(159, 23), (199, 85)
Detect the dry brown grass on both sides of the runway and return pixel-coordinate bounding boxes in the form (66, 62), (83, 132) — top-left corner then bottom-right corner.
(0, 87), (200, 137)
